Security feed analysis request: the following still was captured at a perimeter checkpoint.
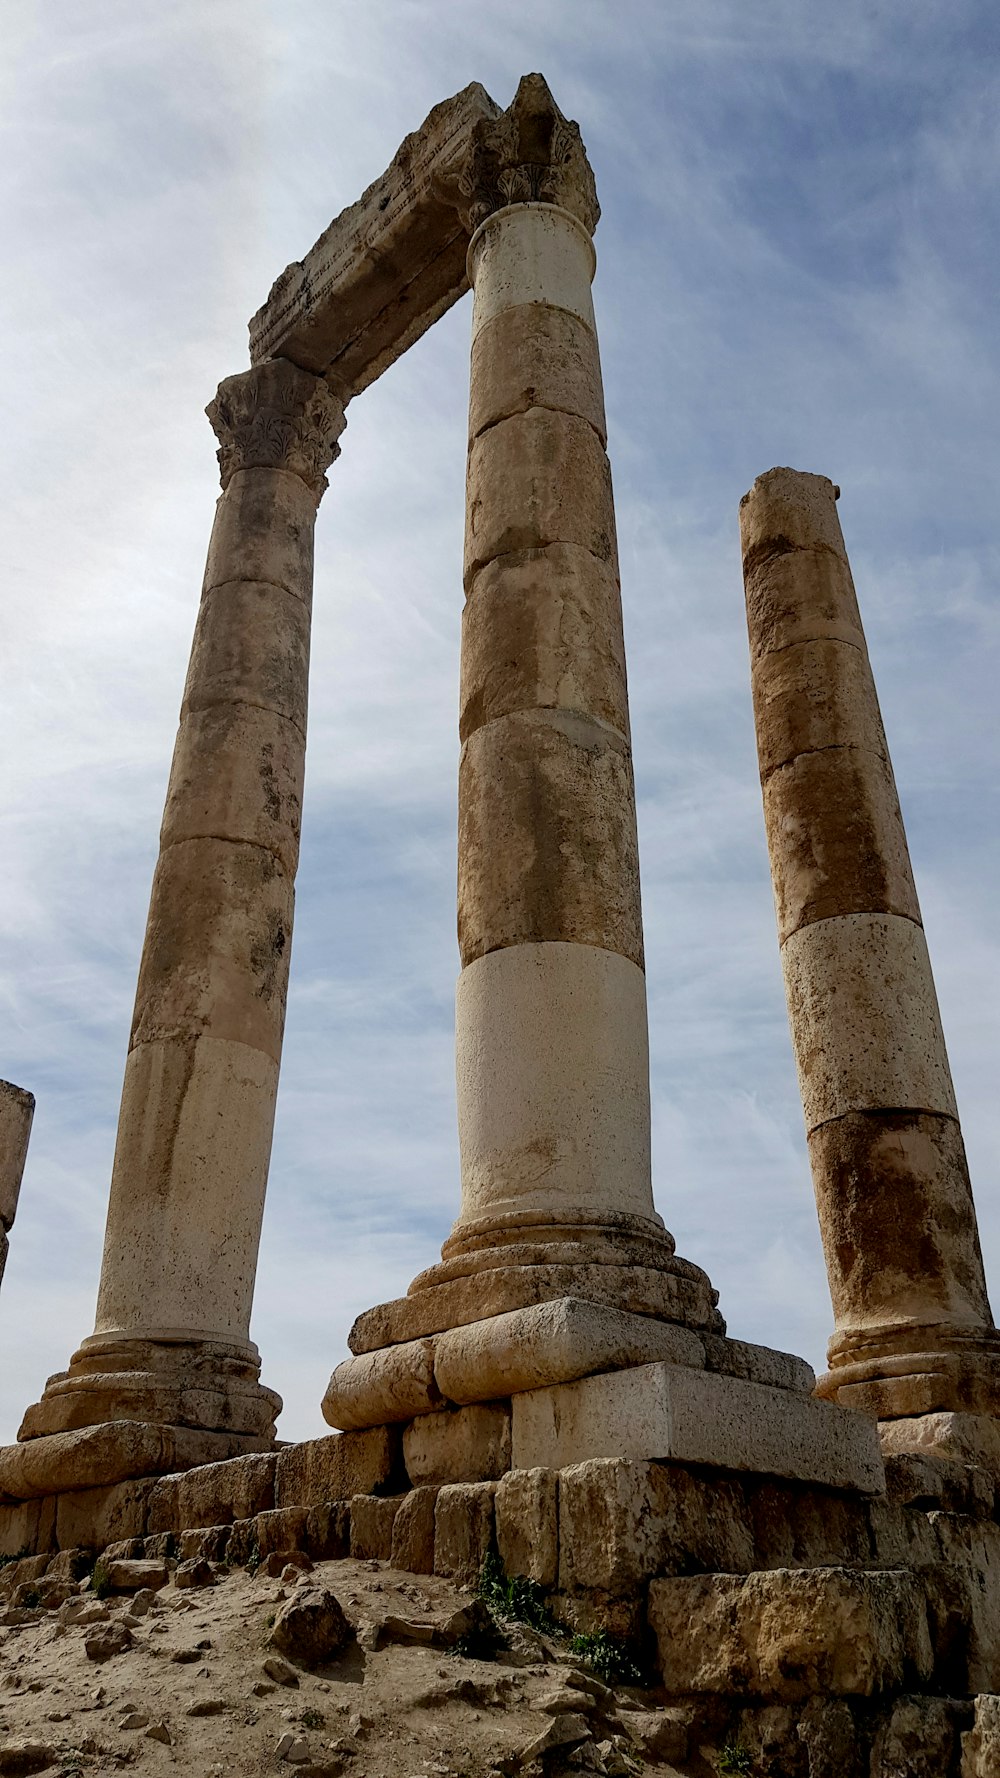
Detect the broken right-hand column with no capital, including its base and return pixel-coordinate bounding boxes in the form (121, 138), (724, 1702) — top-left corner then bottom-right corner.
(740, 469), (1000, 1421)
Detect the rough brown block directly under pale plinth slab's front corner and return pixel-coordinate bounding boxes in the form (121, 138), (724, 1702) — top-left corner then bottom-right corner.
(551, 1458), (754, 1595)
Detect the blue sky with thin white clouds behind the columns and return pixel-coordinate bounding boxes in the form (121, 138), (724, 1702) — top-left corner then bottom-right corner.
(0, 0), (1000, 1442)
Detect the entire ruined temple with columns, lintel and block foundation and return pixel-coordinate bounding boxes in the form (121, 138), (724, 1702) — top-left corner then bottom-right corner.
(0, 75), (1000, 1778)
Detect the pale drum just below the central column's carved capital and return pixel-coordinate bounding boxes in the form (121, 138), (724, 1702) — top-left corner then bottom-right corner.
(468, 204), (598, 340)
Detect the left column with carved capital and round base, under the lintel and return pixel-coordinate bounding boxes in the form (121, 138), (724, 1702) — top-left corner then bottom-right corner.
(20, 359), (343, 1479)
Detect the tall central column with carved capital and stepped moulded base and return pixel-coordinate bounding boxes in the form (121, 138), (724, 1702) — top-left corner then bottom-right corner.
(324, 75), (825, 1456)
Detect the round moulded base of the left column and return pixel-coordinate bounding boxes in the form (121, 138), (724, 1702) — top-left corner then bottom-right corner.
(18, 1332), (281, 1457)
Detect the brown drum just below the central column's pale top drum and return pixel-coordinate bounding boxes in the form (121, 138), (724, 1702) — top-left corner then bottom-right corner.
(468, 302), (607, 445)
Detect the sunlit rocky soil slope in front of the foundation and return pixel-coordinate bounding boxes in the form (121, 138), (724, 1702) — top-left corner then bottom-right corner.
(0, 1558), (690, 1778)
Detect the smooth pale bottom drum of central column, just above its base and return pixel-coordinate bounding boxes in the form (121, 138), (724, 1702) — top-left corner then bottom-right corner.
(456, 942), (653, 1225)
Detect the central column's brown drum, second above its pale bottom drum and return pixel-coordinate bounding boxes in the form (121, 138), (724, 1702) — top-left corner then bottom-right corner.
(459, 544), (630, 741)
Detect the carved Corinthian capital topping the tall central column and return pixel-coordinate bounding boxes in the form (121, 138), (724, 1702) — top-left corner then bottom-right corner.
(438, 75), (601, 235)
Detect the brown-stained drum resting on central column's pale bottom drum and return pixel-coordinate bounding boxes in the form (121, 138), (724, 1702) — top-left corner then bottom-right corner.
(457, 709), (642, 967)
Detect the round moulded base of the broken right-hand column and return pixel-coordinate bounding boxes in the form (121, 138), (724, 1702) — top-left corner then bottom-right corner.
(817, 1323), (1000, 1421)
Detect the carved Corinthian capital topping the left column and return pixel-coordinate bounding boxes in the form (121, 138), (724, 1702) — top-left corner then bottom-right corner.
(205, 357), (347, 500)
